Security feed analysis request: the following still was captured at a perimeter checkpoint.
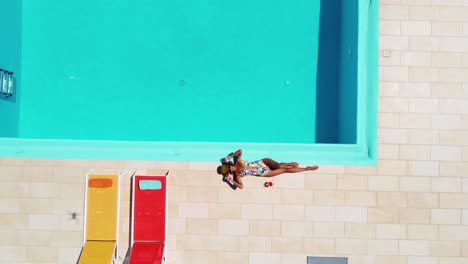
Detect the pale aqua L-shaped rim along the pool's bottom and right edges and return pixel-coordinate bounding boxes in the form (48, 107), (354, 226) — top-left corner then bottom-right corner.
(0, 0), (378, 166)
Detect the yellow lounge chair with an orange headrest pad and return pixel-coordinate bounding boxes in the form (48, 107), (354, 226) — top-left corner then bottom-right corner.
(78, 171), (120, 264)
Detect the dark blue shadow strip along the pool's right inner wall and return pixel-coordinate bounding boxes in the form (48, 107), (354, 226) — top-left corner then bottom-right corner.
(315, 0), (358, 144)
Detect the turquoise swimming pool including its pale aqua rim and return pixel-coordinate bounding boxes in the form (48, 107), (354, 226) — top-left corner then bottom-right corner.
(0, 0), (378, 165)
